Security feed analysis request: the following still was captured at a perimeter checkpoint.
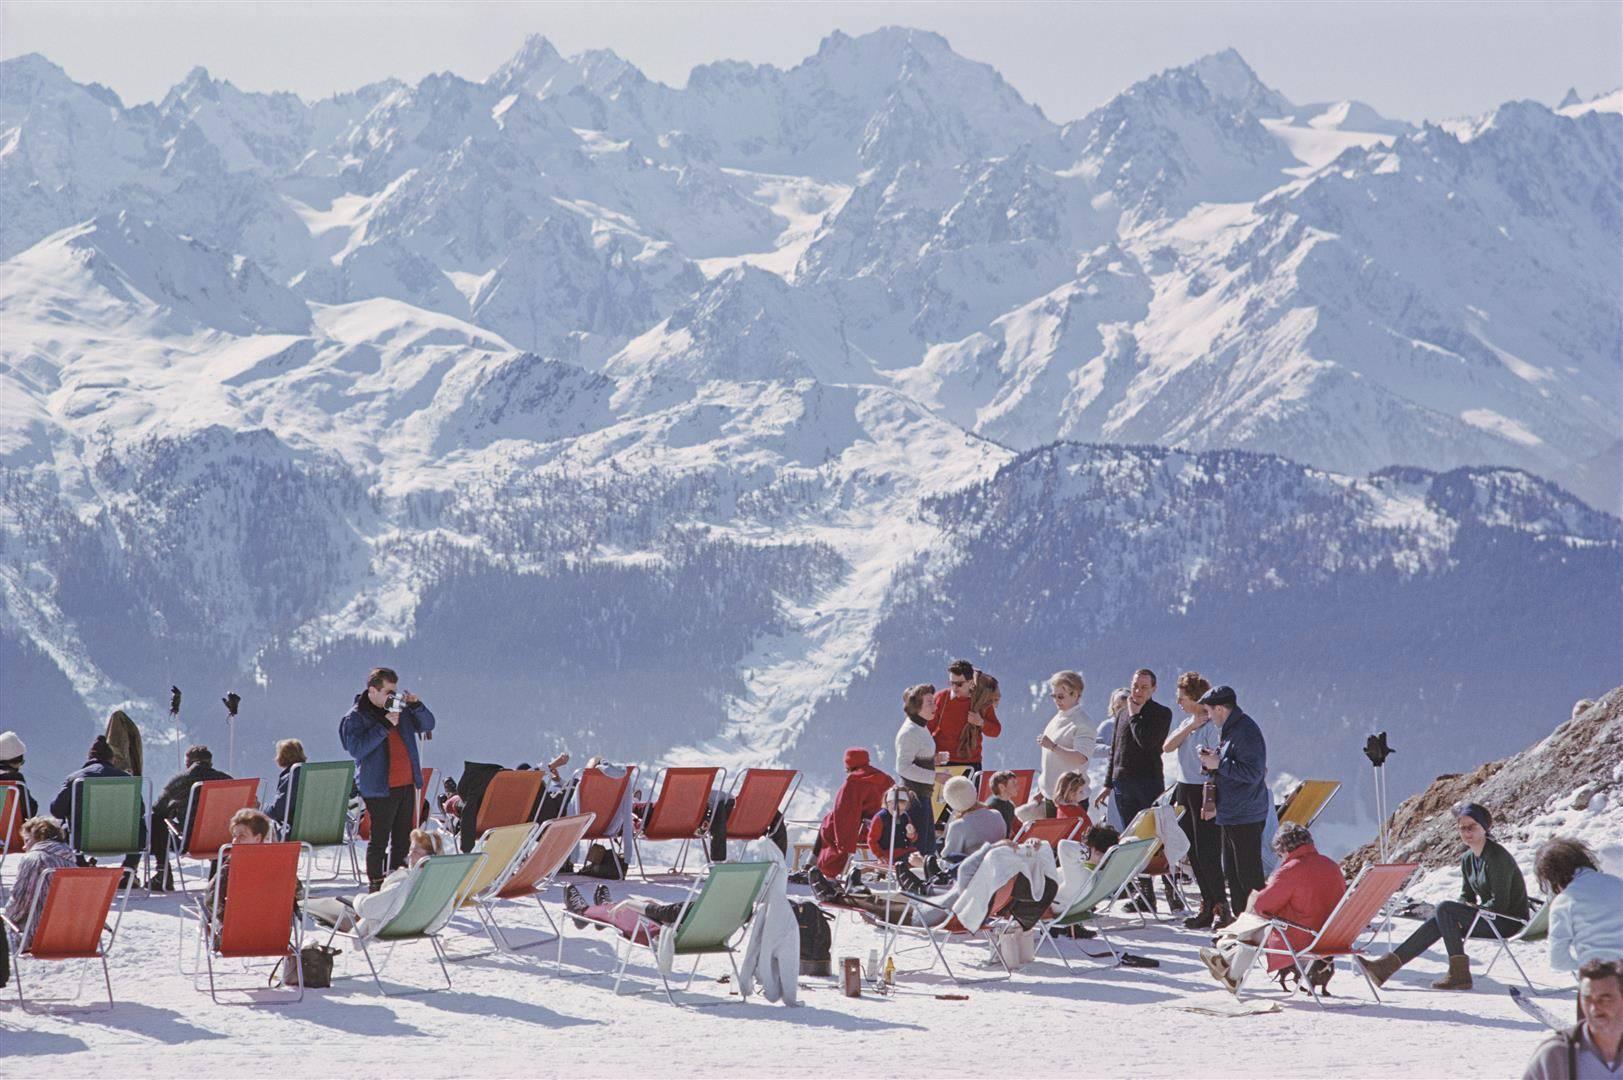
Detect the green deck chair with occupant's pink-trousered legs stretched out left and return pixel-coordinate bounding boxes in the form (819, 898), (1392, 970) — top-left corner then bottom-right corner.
(579, 862), (777, 1005)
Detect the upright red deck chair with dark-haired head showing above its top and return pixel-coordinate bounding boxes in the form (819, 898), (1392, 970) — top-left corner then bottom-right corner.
(192, 844), (305, 1005)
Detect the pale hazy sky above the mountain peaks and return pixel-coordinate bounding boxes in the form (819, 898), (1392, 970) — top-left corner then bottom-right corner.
(0, 0), (1623, 122)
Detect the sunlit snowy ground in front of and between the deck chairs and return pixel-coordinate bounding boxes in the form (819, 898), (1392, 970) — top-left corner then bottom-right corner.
(0, 844), (1571, 1077)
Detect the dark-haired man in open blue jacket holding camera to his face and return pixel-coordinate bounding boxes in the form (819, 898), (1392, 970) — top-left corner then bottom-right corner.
(338, 667), (433, 892)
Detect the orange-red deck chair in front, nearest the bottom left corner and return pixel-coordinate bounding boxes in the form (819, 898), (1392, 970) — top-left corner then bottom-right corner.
(0, 866), (130, 1012)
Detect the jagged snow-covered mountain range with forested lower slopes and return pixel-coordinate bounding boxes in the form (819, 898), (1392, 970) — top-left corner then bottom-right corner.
(0, 28), (1623, 808)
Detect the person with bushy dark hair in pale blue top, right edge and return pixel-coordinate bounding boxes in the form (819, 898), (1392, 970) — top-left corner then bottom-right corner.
(1534, 836), (1623, 971)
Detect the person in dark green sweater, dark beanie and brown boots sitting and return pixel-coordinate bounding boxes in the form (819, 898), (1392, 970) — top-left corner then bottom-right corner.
(1357, 802), (1527, 991)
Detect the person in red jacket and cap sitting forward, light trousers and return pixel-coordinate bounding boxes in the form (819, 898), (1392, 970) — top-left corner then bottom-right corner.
(1201, 822), (1347, 994)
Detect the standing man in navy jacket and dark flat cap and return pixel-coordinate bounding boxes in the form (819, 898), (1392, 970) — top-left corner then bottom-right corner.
(1199, 687), (1269, 919)
